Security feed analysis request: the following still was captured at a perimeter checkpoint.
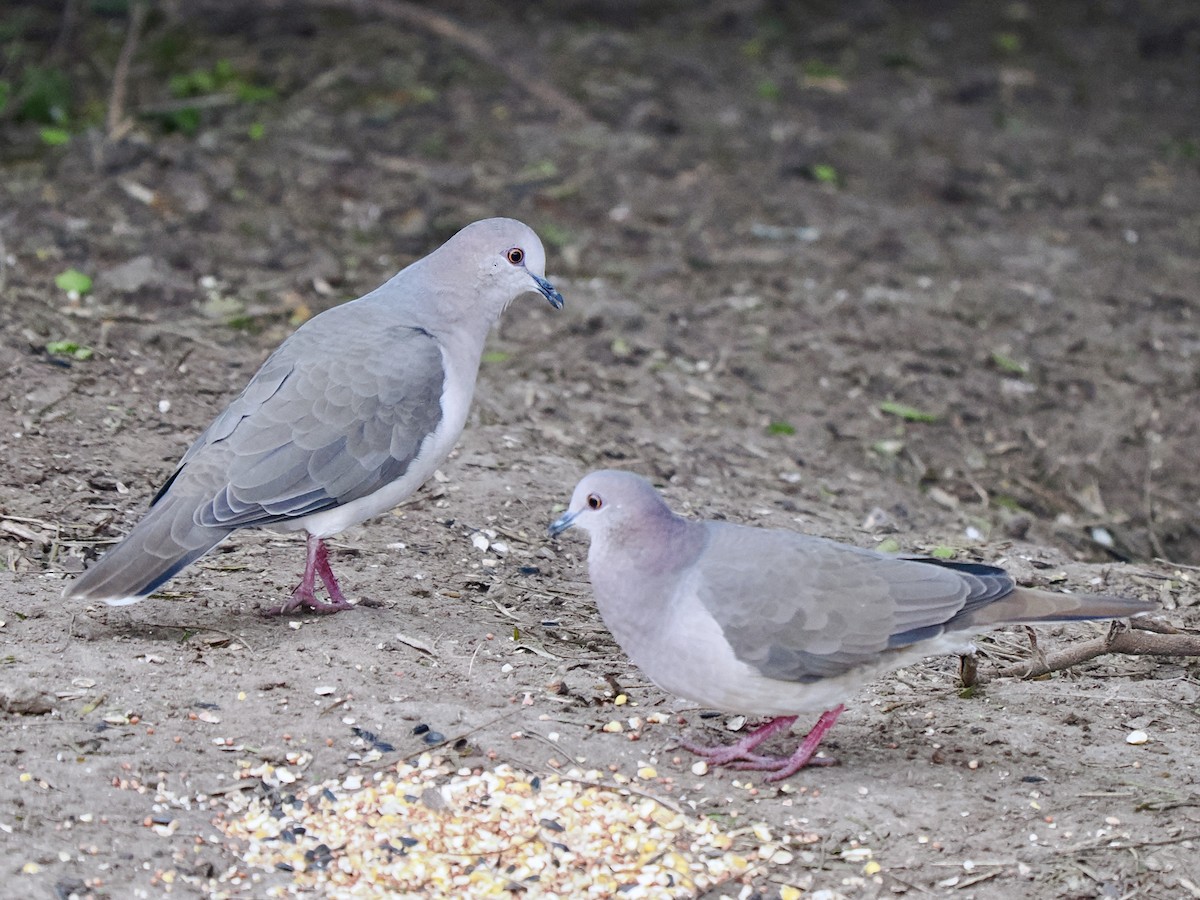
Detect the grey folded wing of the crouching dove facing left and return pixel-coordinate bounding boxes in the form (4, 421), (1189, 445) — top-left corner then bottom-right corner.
(689, 523), (1013, 682)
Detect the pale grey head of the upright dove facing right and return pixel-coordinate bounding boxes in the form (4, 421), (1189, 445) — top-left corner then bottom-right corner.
(428, 218), (563, 322)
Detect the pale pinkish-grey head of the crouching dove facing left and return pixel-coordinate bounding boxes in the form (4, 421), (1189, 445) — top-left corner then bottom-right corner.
(550, 469), (679, 542)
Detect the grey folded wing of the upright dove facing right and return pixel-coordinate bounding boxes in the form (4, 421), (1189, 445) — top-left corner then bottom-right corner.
(155, 310), (445, 529)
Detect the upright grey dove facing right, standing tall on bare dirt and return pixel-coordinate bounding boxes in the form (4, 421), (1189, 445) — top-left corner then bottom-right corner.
(65, 218), (563, 613)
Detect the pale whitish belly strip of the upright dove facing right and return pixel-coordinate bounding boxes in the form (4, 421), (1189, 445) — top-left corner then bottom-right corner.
(288, 347), (478, 538)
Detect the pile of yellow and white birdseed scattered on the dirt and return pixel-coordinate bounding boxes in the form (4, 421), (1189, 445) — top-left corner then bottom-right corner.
(217, 754), (790, 898)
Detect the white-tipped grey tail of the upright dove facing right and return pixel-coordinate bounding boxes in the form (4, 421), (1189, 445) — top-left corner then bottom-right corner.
(62, 497), (229, 606)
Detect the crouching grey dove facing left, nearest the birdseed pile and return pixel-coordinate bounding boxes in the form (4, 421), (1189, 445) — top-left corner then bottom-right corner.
(550, 472), (1154, 781)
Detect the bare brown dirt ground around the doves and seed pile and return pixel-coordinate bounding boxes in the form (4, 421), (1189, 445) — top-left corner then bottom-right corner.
(0, 0), (1200, 899)
